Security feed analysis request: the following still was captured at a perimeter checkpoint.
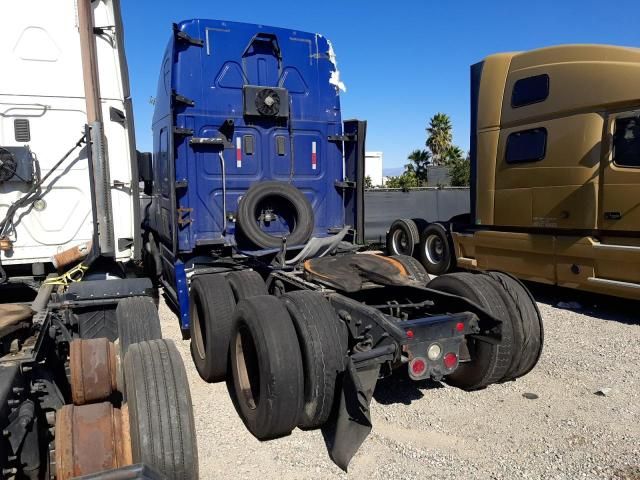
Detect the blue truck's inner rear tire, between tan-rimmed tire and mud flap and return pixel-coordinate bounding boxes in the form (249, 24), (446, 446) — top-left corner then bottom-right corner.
(280, 290), (347, 430)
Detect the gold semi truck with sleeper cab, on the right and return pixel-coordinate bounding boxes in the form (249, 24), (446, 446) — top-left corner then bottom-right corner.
(387, 45), (640, 299)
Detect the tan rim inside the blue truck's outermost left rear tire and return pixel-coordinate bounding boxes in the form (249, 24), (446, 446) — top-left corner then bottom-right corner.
(235, 326), (260, 410)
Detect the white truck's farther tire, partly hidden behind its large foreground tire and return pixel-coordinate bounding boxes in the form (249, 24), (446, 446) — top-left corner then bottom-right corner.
(116, 297), (162, 358)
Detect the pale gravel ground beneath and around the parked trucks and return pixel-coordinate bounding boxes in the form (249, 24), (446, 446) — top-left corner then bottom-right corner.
(160, 290), (640, 480)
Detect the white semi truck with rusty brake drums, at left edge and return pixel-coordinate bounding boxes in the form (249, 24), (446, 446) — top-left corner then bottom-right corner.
(0, 0), (198, 480)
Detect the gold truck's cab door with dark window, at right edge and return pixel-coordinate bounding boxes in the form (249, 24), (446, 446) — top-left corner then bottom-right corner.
(598, 108), (640, 232)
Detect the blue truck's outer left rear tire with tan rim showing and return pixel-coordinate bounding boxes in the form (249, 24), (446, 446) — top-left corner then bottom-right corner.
(227, 296), (304, 440)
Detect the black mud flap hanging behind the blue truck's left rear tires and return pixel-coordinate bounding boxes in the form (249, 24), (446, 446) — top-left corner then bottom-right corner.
(322, 359), (380, 472)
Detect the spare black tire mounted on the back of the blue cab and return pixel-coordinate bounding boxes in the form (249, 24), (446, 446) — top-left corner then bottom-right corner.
(237, 182), (314, 248)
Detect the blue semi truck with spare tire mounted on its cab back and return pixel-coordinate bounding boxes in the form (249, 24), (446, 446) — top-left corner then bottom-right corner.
(140, 19), (542, 469)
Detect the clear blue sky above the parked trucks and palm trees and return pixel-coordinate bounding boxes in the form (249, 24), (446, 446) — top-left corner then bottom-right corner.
(122, 0), (640, 169)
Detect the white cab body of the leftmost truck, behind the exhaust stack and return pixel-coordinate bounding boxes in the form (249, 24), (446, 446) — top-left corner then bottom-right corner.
(0, 0), (140, 278)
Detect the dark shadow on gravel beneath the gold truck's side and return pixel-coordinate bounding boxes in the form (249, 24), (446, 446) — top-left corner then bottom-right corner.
(526, 282), (640, 325)
